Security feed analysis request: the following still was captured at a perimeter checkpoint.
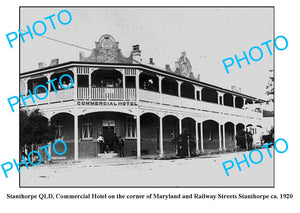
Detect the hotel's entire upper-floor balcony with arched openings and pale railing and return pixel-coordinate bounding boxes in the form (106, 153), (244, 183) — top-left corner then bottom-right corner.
(21, 68), (261, 120)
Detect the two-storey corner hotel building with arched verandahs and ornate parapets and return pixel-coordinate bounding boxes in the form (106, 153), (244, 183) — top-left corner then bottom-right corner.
(20, 35), (264, 160)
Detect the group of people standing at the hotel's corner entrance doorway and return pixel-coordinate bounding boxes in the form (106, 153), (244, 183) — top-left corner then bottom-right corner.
(97, 132), (125, 157)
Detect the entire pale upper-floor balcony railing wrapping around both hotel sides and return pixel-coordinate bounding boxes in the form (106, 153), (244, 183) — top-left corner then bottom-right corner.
(20, 87), (262, 120)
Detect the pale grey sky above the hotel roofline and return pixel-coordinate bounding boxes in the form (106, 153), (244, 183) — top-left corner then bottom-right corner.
(20, 7), (274, 99)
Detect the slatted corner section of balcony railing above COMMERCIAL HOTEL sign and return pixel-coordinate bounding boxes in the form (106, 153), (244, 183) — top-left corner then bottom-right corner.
(77, 87), (136, 100)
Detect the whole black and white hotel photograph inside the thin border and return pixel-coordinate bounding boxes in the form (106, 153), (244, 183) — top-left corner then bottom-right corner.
(18, 7), (274, 187)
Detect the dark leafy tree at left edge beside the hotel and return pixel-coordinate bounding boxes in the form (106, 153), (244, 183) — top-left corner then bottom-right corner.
(20, 109), (53, 147)
